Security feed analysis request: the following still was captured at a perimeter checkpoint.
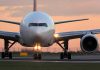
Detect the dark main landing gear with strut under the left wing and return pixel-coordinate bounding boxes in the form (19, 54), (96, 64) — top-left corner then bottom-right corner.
(1, 40), (16, 59)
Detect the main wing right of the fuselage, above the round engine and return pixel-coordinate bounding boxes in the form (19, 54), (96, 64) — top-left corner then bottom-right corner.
(55, 29), (100, 41)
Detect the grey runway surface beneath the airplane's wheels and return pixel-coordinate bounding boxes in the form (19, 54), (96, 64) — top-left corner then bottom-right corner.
(0, 55), (100, 63)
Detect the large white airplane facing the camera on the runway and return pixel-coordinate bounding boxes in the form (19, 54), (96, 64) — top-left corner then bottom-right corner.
(0, 0), (100, 60)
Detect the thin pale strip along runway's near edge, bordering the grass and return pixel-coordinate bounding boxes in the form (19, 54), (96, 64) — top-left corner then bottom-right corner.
(0, 59), (100, 63)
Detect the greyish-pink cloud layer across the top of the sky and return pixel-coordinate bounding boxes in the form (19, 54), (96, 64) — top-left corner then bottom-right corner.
(0, 0), (100, 17)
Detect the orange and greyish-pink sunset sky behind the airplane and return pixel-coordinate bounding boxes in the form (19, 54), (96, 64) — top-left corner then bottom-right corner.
(0, 0), (100, 51)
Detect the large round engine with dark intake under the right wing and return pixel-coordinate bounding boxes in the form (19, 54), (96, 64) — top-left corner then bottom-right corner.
(80, 34), (98, 52)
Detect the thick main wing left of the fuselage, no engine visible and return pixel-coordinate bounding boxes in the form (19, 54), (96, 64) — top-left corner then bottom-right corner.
(0, 31), (20, 42)
